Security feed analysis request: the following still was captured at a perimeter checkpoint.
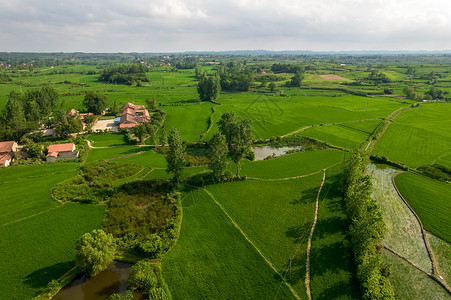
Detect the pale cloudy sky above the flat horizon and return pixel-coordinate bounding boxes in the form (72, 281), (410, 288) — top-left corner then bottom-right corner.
(0, 0), (451, 52)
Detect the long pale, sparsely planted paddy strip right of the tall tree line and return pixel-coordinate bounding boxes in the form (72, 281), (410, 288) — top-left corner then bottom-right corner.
(367, 164), (432, 273)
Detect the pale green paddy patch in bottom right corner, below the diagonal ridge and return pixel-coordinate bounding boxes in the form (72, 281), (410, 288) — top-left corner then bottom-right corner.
(383, 250), (451, 300)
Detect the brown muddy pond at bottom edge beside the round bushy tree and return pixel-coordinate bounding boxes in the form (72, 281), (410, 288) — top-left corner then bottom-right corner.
(52, 262), (142, 300)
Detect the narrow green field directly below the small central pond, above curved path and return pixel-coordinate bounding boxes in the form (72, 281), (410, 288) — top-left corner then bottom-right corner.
(228, 150), (345, 179)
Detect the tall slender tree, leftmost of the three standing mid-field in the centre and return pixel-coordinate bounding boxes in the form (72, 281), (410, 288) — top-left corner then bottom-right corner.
(166, 128), (186, 184)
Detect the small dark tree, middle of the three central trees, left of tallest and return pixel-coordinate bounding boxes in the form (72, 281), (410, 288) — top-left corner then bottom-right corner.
(207, 133), (229, 180)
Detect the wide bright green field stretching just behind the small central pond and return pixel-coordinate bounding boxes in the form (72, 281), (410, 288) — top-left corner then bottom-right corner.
(206, 94), (404, 140)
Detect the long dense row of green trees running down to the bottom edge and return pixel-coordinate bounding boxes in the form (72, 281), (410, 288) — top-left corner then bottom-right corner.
(343, 152), (394, 299)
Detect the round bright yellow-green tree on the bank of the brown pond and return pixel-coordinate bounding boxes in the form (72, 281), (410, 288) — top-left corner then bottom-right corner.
(75, 229), (116, 276)
